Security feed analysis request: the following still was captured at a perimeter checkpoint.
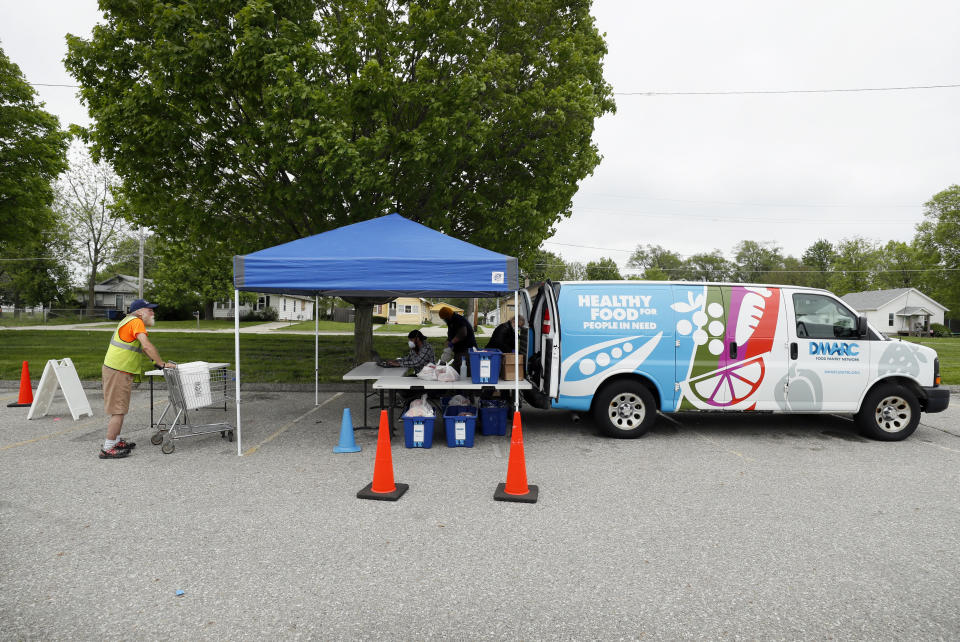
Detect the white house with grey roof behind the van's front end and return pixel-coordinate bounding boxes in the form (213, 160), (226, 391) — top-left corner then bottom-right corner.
(841, 288), (948, 334)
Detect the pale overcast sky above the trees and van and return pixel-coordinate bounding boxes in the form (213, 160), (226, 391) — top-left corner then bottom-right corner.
(0, 0), (960, 267)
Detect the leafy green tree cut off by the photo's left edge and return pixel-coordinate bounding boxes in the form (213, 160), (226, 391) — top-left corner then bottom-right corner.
(0, 49), (68, 248)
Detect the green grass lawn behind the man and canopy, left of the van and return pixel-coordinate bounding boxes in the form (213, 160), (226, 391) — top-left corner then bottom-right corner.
(0, 330), (407, 380)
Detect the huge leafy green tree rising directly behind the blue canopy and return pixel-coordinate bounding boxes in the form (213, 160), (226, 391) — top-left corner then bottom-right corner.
(66, 0), (614, 360)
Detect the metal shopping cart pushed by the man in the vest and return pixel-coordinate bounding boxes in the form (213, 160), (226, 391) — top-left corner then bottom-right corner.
(150, 364), (235, 455)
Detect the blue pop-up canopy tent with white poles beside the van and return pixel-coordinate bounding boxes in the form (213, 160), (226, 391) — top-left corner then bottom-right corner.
(233, 214), (520, 455)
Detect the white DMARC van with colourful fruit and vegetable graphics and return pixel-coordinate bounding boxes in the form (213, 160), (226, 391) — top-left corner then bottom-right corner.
(521, 281), (950, 441)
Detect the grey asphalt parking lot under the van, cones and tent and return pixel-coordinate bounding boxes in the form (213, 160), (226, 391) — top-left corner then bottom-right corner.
(0, 382), (960, 640)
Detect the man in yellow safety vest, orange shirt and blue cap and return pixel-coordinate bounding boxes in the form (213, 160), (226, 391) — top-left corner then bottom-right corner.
(100, 299), (176, 459)
